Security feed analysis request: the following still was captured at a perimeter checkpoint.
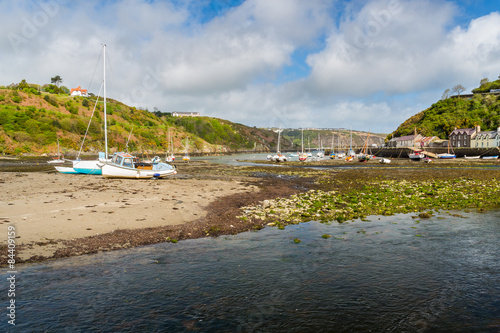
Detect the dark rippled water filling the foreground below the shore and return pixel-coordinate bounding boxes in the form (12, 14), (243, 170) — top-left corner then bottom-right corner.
(0, 211), (500, 332)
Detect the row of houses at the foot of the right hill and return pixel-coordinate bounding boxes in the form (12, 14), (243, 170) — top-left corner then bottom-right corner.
(387, 126), (500, 148)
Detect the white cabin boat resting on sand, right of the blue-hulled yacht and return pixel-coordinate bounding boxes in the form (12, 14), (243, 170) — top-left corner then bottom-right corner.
(101, 152), (177, 179)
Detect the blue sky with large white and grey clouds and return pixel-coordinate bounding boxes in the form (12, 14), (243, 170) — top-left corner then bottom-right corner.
(0, 0), (500, 133)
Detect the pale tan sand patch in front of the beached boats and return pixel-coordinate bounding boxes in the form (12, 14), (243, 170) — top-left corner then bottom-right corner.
(0, 172), (258, 260)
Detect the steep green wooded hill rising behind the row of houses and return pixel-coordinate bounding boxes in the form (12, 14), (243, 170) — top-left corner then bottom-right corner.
(388, 79), (500, 139)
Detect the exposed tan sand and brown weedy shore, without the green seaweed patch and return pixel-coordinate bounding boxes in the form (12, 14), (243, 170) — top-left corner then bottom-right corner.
(0, 162), (500, 266)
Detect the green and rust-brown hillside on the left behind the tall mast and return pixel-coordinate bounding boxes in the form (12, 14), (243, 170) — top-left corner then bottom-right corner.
(0, 80), (291, 155)
